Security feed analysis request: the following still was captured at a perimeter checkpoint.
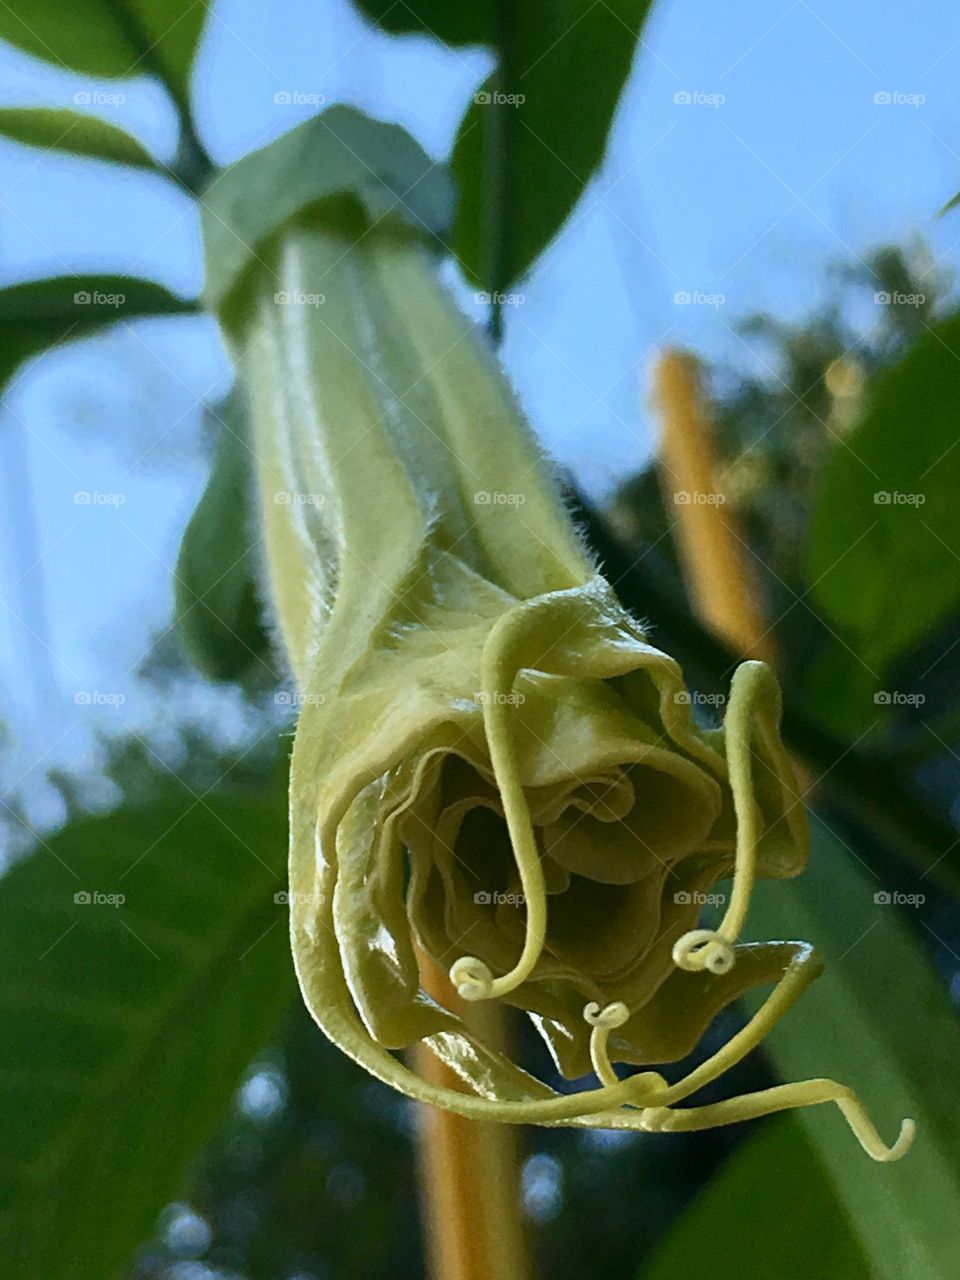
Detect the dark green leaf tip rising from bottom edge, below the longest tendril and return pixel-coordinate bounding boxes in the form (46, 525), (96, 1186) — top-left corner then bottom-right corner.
(640, 1115), (873, 1280)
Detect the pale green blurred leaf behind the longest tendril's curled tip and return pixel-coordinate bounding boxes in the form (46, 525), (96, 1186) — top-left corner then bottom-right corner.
(748, 822), (960, 1280)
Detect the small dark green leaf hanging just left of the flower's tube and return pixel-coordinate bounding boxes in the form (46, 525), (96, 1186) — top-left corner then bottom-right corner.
(174, 403), (274, 680)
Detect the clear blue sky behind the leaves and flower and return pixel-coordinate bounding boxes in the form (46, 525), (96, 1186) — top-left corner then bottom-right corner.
(0, 0), (960, 819)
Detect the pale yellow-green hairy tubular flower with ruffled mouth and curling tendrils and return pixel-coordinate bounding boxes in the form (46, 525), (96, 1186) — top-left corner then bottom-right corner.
(207, 129), (910, 1160)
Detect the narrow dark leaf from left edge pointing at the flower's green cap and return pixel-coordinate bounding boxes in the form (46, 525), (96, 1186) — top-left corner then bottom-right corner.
(0, 275), (196, 390)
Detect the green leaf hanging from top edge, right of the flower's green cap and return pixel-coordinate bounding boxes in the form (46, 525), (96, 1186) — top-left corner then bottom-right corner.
(452, 0), (650, 291)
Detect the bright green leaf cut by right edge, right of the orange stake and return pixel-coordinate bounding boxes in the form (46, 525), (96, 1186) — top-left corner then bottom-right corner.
(806, 316), (960, 668)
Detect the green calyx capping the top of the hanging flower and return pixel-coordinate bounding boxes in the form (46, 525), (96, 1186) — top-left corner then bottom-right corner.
(201, 106), (453, 320)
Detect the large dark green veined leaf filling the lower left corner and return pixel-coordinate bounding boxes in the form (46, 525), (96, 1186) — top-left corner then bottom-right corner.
(0, 785), (294, 1280)
